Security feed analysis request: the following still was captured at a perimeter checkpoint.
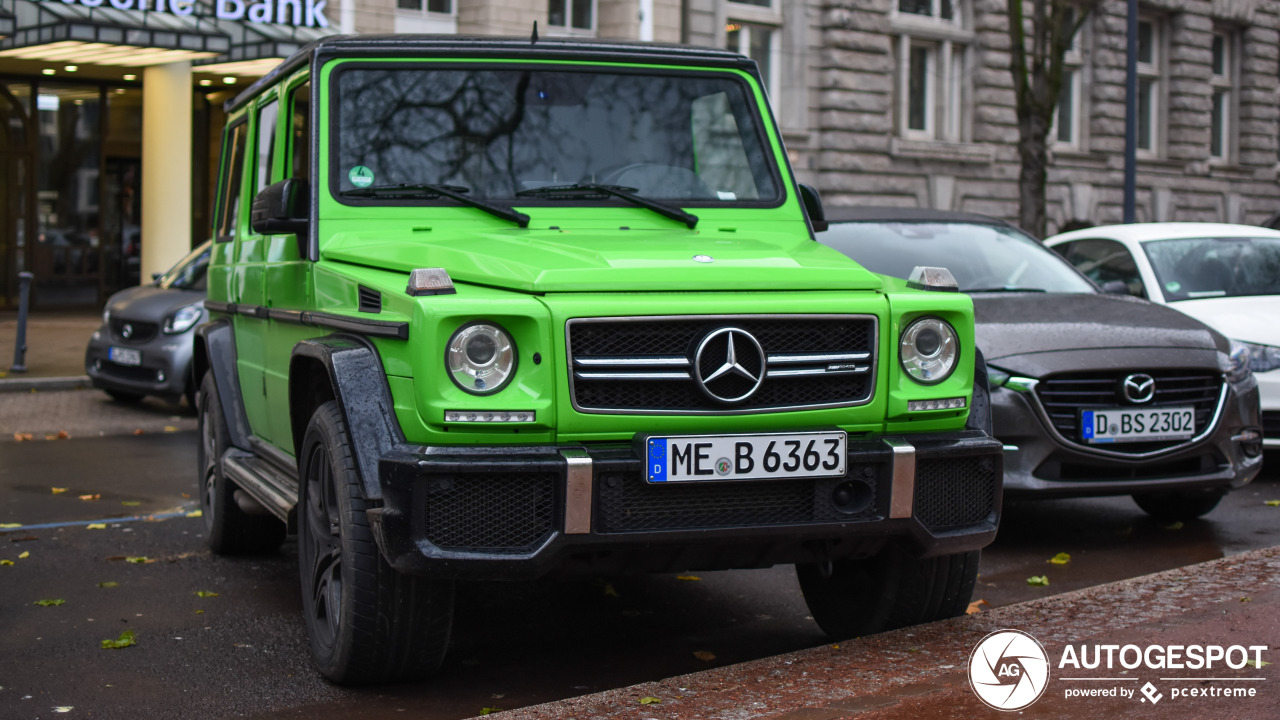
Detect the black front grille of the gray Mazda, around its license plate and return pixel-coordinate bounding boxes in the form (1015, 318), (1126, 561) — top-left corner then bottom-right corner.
(1036, 370), (1222, 454)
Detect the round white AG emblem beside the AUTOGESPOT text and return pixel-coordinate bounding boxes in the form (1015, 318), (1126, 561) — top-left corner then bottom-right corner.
(969, 630), (1048, 710)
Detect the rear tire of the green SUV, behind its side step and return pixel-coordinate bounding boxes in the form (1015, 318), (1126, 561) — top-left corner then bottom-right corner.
(196, 373), (285, 555)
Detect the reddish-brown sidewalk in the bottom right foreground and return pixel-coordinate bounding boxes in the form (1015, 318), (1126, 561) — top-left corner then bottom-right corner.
(499, 548), (1280, 720)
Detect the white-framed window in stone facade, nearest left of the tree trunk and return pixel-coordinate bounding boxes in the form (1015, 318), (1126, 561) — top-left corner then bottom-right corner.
(891, 0), (973, 142)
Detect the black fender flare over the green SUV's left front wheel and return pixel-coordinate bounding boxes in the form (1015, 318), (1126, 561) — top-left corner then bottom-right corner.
(289, 333), (404, 500)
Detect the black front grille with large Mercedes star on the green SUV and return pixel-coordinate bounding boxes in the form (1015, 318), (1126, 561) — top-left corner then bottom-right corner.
(566, 315), (876, 414)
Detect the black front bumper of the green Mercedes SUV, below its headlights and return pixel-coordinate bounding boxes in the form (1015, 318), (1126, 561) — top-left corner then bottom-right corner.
(369, 432), (1002, 579)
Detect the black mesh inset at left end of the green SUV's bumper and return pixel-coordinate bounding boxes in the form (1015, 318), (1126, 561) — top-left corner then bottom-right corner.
(424, 473), (556, 553)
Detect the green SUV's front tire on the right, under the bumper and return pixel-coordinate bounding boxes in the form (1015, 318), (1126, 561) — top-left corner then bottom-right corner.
(796, 544), (980, 639)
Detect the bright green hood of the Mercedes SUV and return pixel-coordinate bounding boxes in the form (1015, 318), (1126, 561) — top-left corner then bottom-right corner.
(321, 225), (882, 293)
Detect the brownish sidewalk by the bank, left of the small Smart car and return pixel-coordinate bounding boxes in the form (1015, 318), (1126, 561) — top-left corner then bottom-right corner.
(0, 310), (102, 392)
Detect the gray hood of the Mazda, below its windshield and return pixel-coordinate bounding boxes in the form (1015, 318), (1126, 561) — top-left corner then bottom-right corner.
(973, 292), (1229, 365)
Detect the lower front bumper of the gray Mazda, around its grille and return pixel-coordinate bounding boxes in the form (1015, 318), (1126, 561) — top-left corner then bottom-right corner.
(991, 383), (1262, 497)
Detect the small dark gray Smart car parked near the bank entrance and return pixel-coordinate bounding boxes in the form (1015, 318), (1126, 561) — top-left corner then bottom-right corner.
(84, 235), (210, 407)
